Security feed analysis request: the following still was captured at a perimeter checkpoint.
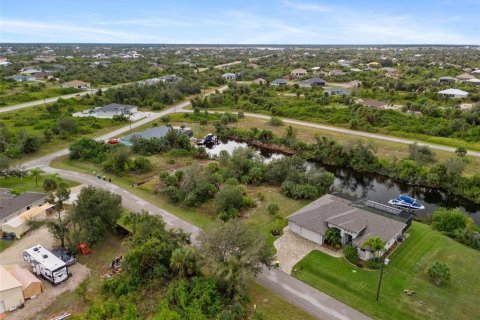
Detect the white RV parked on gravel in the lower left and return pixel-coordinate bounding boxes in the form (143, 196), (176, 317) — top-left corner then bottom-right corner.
(23, 244), (69, 285)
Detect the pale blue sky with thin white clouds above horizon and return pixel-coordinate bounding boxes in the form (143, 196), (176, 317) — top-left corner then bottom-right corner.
(0, 0), (480, 45)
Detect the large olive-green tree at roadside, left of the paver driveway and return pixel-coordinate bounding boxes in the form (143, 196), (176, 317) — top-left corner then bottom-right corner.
(198, 220), (273, 297)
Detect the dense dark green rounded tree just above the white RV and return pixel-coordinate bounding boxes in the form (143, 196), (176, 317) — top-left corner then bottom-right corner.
(69, 186), (122, 245)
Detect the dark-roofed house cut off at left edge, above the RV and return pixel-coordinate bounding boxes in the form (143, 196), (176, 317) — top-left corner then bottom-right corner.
(0, 188), (47, 222)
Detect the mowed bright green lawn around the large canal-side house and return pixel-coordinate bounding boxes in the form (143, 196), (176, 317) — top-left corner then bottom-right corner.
(294, 222), (480, 320)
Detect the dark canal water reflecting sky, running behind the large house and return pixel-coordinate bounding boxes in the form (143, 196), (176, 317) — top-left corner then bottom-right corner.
(202, 140), (480, 225)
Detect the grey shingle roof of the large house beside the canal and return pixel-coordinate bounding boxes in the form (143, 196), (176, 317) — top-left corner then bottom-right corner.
(288, 194), (406, 246)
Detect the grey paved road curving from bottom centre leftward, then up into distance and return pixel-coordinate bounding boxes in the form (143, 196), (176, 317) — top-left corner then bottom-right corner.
(23, 87), (370, 320)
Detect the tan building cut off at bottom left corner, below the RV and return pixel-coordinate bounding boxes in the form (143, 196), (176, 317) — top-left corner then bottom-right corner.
(0, 266), (25, 319)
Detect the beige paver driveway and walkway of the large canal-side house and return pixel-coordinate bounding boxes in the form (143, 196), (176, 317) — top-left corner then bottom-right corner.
(273, 230), (342, 274)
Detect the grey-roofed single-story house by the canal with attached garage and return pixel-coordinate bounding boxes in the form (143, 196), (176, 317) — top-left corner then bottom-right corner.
(288, 194), (407, 260)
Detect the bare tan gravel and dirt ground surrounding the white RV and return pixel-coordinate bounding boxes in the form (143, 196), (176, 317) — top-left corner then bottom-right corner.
(0, 228), (90, 320)
